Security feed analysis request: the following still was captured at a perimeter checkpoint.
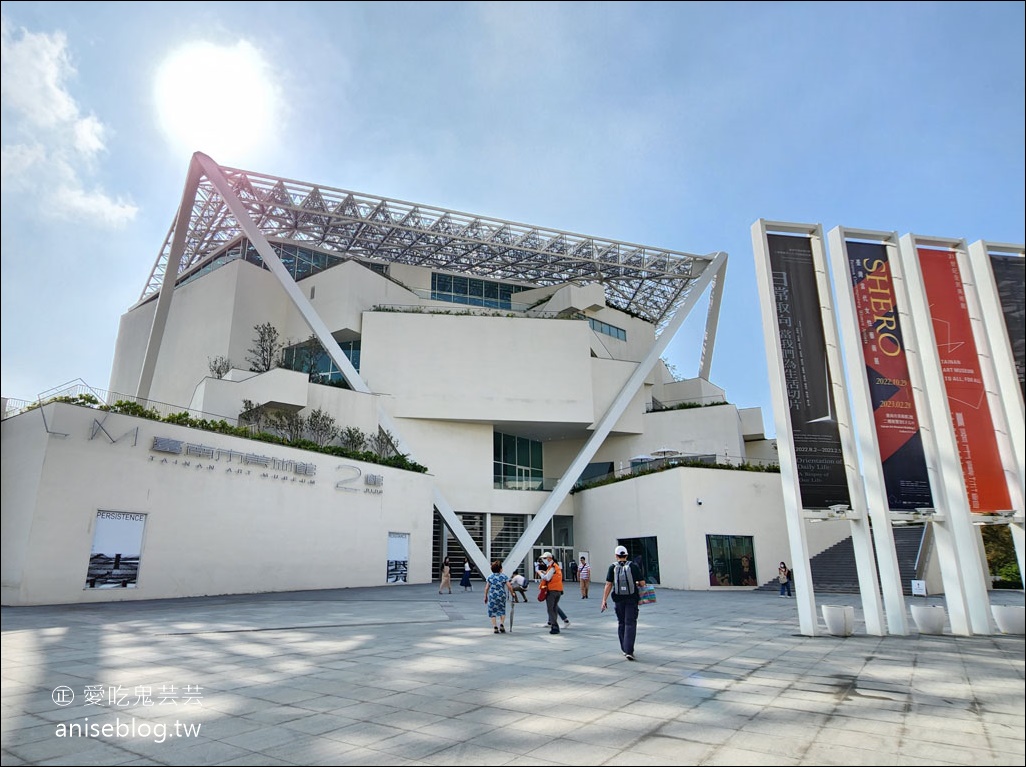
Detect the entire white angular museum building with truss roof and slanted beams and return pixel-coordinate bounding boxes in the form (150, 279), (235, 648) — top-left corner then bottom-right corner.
(2, 154), (849, 605)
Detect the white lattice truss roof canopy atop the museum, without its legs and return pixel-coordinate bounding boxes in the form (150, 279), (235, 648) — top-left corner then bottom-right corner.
(140, 166), (716, 329)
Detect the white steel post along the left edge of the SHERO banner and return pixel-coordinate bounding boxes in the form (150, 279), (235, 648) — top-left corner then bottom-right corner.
(829, 227), (908, 636)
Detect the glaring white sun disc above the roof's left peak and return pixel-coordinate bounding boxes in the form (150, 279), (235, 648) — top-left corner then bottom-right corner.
(154, 41), (283, 164)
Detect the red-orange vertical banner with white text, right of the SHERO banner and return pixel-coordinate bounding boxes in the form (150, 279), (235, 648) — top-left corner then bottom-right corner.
(917, 247), (1012, 514)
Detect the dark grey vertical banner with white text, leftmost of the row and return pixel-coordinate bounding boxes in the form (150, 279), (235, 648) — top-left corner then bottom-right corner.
(766, 234), (852, 509)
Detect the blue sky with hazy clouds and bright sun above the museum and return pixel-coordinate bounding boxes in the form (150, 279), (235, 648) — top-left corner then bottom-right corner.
(0, 2), (1026, 434)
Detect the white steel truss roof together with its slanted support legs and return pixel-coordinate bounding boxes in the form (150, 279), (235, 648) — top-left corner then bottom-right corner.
(136, 152), (726, 572)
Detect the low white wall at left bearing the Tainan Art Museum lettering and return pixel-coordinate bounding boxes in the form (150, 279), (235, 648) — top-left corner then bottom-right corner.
(2, 404), (433, 605)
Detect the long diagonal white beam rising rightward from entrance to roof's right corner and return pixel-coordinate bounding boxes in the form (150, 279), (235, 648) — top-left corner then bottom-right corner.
(503, 252), (726, 571)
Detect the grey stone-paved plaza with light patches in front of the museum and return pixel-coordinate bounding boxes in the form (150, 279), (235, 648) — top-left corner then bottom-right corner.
(0, 584), (1026, 767)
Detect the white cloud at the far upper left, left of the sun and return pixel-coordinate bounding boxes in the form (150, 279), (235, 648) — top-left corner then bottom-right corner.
(0, 17), (137, 228)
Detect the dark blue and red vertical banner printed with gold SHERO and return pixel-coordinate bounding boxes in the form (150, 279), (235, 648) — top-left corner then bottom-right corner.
(845, 241), (934, 511)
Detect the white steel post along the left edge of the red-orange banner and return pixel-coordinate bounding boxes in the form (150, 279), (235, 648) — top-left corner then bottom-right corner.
(899, 234), (993, 636)
